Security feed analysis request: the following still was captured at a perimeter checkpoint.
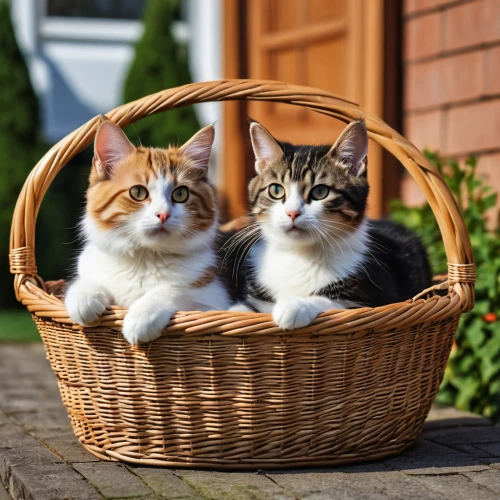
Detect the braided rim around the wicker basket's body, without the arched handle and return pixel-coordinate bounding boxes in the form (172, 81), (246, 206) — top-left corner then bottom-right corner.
(23, 280), (467, 338)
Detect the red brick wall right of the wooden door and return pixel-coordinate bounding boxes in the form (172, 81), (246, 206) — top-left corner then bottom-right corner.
(403, 0), (500, 209)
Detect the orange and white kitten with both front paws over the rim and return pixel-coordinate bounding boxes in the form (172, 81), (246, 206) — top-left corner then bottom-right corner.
(65, 120), (230, 344)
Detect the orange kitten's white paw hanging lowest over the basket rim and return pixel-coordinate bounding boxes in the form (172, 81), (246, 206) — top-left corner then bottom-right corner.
(123, 299), (176, 345)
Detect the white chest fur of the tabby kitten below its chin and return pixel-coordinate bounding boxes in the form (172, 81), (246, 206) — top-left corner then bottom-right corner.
(250, 227), (368, 301)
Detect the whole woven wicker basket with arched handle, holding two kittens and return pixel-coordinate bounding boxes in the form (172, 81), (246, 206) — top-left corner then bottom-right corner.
(10, 80), (475, 469)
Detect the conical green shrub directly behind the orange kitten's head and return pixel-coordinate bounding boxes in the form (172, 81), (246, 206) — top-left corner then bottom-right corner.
(123, 0), (200, 147)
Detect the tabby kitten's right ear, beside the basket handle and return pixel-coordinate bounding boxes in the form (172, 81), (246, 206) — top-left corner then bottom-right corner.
(328, 120), (368, 177)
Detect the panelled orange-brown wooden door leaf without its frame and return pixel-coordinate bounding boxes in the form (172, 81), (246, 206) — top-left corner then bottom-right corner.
(247, 0), (362, 144)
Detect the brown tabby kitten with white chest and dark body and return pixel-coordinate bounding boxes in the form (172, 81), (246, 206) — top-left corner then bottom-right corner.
(233, 120), (431, 330)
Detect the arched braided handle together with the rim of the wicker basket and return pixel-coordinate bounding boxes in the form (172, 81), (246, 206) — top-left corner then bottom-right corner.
(9, 80), (475, 335)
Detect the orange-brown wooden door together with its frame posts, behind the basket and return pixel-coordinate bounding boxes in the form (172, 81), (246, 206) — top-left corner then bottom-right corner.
(223, 0), (384, 221)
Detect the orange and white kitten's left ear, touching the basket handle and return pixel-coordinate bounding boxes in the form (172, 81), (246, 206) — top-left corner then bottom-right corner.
(94, 115), (135, 180)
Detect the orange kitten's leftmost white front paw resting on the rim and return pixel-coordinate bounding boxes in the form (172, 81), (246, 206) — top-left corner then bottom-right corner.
(64, 281), (113, 326)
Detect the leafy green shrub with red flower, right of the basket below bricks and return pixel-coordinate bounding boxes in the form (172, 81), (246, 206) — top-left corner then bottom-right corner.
(391, 152), (500, 420)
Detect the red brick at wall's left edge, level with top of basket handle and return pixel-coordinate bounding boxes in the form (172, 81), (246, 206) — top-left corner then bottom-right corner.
(405, 50), (484, 110)
